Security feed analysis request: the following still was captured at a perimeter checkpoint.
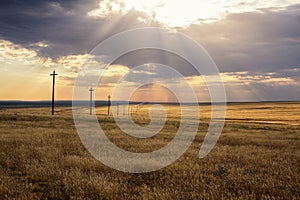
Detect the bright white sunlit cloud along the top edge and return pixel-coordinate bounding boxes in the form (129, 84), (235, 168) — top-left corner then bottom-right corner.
(88, 0), (299, 27)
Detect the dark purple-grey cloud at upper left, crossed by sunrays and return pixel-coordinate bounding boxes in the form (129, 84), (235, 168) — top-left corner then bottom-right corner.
(0, 0), (151, 58)
